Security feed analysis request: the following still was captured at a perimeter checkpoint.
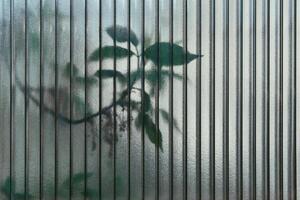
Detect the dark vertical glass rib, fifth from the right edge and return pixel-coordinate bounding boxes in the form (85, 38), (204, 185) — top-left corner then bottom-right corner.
(237, 0), (243, 200)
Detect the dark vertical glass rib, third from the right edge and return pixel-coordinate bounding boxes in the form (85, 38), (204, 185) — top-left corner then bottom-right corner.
(263, 0), (270, 200)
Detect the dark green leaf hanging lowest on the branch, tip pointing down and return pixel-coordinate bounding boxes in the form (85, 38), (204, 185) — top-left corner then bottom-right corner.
(135, 113), (163, 151)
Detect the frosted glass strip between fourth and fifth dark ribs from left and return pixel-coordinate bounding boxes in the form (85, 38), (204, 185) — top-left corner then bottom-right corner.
(56, 1), (71, 197)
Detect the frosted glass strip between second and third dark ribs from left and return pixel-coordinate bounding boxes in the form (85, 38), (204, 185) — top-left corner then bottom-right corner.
(27, 0), (40, 196)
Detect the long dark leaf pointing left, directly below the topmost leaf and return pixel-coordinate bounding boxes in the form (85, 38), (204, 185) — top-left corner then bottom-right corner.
(89, 46), (134, 61)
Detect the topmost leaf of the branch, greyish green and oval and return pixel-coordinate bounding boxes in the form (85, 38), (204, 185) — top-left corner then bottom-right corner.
(106, 25), (139, 46)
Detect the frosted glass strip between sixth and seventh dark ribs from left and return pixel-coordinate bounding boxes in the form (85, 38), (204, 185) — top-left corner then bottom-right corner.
(85, 0), (100, 199)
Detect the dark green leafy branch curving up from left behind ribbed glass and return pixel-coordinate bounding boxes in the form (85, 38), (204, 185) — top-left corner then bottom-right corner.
(5, 25), (199, 150)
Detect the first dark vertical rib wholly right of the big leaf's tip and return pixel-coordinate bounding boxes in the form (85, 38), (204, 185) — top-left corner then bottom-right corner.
(209, 0), (216, 199)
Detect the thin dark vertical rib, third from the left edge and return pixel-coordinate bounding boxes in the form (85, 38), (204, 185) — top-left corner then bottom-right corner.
(39, 0), (44, 200)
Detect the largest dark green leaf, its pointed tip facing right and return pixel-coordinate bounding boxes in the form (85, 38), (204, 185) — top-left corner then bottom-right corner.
(145, 42), (199, 66)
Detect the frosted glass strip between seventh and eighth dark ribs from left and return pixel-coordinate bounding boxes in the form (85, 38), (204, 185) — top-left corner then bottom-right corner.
(101, 0), (115, 199)
